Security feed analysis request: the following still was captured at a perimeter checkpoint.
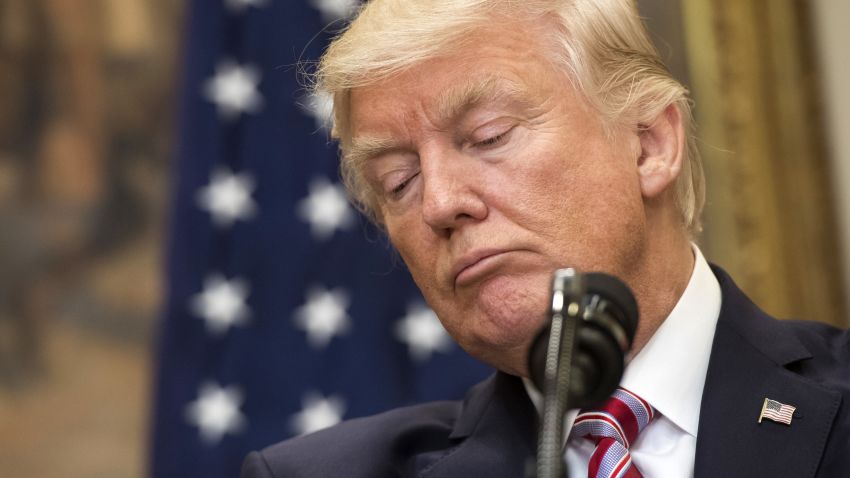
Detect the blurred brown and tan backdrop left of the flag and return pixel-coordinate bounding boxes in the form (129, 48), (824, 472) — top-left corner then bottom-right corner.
(0, 0), (185, 477)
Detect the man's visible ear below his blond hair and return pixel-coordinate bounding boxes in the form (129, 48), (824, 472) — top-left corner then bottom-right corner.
(637, 104), (685, 198)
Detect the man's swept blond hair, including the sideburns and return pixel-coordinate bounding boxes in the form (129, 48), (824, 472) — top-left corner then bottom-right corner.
(314, 0), (705, 235)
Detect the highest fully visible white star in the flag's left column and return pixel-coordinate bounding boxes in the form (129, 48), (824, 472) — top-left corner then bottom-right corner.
(204, 61), (263, 120)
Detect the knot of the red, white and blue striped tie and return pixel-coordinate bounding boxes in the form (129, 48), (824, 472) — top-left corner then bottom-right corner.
(571, 388), (655, 448)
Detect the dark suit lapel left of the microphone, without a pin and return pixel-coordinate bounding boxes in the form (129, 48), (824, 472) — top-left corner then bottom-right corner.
(413, 372), (536, 478)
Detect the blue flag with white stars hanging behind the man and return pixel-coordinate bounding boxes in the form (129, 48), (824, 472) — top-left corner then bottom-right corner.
(149, 0), (490, 478)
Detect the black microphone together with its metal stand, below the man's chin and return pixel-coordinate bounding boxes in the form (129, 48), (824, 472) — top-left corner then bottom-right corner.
(527, 269), (638, 478)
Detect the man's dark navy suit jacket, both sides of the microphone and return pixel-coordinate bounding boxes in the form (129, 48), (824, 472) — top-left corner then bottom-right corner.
(242, 269), (850, 478)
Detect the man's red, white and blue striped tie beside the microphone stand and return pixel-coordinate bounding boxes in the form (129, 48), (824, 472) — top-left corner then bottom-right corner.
(570, 388), (655, 478)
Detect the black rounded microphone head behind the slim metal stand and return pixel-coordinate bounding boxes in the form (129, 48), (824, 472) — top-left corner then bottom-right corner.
(529, 269), (638, 408)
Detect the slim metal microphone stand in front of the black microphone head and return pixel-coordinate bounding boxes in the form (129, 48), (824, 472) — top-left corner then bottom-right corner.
(537, 269), (585, 478)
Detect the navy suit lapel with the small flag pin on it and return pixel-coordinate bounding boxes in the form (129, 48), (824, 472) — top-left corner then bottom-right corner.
(694, 269), (841, 478)
